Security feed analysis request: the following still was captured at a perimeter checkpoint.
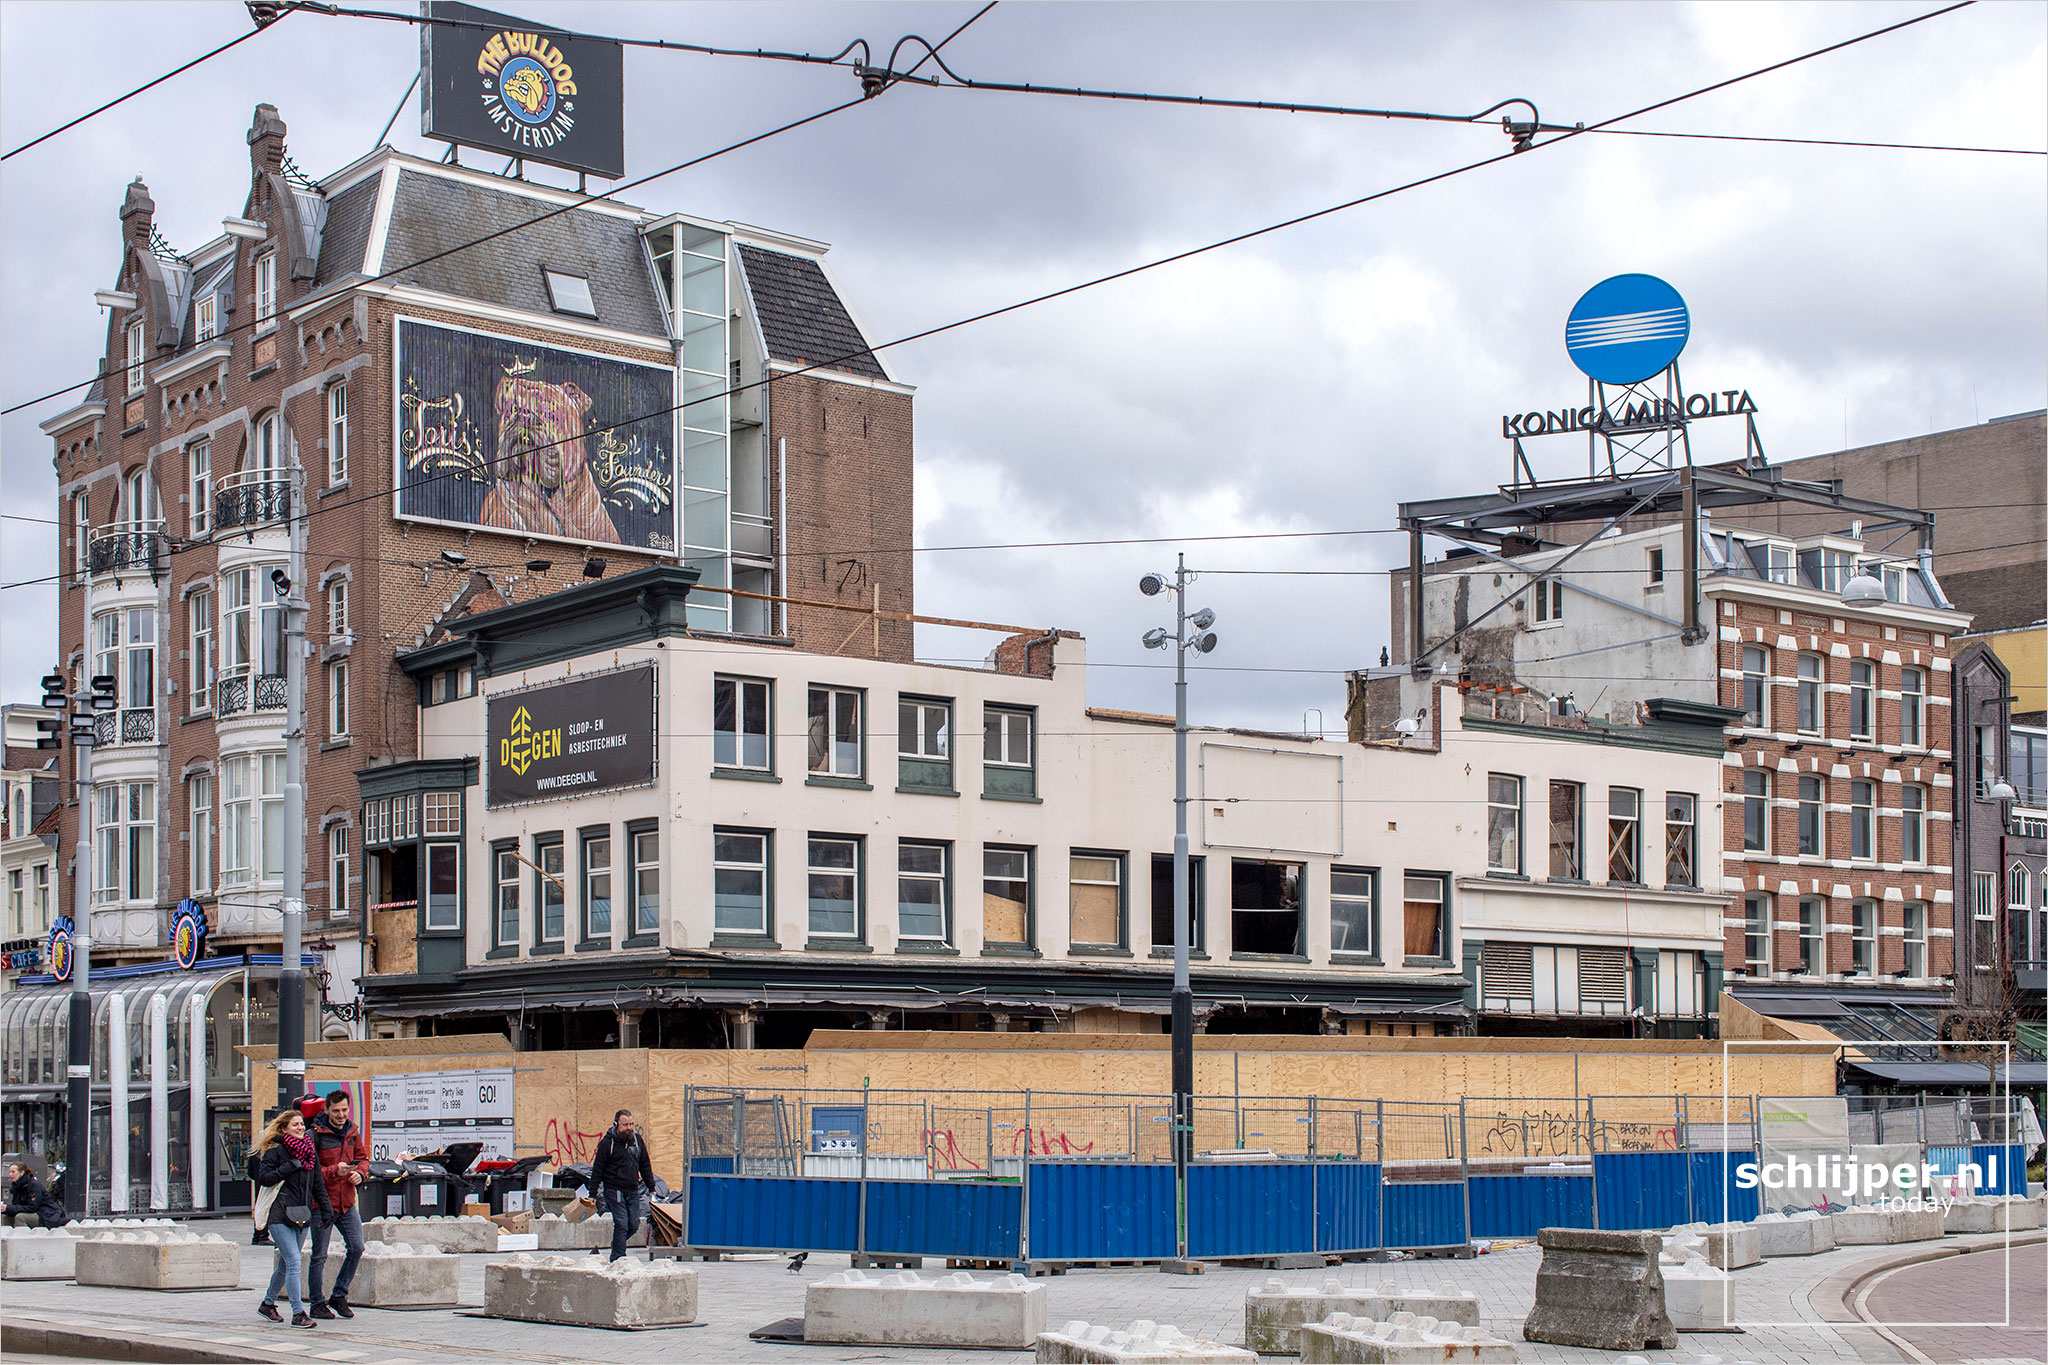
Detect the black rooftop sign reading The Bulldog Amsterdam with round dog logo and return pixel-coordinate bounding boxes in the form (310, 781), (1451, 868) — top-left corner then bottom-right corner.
(420, 0), (625, 180)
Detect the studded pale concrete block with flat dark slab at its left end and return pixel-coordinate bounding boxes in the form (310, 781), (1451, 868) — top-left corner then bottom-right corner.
(803, 1271), (1044, 1351)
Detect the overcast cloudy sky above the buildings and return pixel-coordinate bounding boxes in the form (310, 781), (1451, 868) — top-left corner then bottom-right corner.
(0, 0), (2048, 731)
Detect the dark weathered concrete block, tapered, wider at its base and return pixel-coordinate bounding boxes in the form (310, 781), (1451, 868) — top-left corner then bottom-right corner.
(1522, 1228), (1677, 1351)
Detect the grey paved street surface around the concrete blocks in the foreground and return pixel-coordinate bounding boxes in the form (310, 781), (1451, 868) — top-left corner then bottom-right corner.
(6, 1238), (2044, 1365)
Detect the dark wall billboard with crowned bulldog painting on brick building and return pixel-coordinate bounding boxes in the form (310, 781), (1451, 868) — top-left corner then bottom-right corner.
(391, 317), (676, 553)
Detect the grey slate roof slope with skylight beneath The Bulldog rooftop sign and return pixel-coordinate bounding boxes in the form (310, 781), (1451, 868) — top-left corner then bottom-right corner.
(383, 168), (668, 344)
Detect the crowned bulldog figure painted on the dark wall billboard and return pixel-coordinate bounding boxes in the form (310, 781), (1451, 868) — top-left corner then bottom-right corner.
(477, 372), (621, 544)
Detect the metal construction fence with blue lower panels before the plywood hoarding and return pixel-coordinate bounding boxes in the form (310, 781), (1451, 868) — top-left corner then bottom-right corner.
(680, 1087), (2025, 1263)
